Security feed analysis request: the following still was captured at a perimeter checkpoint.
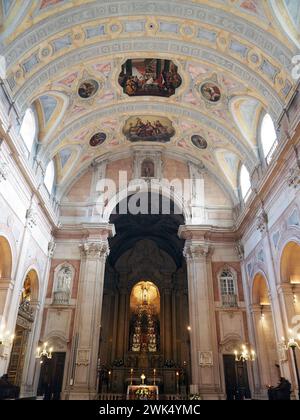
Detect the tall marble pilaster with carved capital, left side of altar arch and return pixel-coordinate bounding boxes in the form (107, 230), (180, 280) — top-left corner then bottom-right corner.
(68, 228), (112, 399)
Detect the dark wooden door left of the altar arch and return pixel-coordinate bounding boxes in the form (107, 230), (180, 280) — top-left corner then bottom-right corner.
(38, 353), (66, 400)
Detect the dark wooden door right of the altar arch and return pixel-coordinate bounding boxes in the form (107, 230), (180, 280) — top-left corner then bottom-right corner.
(223, 354), (251, 400)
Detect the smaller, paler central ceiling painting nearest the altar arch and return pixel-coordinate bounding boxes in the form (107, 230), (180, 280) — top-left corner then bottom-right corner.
(123, 115), (175, 143)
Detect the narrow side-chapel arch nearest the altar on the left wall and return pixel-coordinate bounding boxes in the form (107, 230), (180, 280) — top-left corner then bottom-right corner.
(7, 270), (39, 387)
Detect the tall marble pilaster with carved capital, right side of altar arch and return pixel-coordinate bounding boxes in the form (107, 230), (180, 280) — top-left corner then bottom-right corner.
(180, 235), (221, 399)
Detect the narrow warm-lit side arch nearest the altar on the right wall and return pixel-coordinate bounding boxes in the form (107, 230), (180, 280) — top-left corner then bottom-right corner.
(252, 273), (280, 396)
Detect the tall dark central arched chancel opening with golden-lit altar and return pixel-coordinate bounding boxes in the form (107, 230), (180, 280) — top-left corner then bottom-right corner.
(99, 194), (190, 397)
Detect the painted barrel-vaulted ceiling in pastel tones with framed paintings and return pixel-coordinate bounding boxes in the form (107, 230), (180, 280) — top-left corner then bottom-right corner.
(0, 0), (300, 202)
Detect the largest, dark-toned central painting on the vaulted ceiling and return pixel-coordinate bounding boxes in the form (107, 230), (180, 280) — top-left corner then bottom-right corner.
(119, 58), (182, 98)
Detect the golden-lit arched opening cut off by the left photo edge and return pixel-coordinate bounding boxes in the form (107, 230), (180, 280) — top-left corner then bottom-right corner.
(0, 236), (12, 318)
